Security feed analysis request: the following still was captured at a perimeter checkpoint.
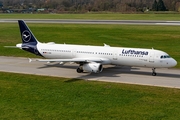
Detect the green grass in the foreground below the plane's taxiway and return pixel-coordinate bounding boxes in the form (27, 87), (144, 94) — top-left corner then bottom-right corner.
(0, 72), (180, 120)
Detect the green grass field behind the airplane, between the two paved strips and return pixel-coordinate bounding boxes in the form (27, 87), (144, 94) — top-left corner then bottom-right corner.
(0, 23), (180, 68)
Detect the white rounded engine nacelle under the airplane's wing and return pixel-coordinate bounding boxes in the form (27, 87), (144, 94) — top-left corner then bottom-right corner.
(82, 62), (103, 73)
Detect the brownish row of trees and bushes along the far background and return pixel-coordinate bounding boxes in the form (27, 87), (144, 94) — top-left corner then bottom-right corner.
(0, 0), (180, 12)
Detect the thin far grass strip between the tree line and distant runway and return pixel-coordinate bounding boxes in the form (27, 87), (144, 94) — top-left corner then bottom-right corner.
(0, 12), (180, 21)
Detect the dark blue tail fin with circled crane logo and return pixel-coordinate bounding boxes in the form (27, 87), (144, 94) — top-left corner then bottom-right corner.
(18, 20), (42, 56)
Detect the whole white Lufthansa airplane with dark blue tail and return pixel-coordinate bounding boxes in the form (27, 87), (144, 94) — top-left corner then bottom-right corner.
(5, 20), (177, 76)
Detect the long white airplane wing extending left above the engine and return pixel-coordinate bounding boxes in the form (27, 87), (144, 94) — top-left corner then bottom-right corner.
(36, 58), (111, 64)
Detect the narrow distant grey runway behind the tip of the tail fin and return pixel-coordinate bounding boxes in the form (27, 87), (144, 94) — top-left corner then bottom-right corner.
(0, 19), (180, 25)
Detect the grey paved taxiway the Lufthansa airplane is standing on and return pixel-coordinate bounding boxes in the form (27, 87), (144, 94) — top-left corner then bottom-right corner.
(0, 56), (180, 88)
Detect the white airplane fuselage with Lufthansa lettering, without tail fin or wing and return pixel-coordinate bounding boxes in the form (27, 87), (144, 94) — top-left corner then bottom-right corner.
(37, 43), (177, 68)
